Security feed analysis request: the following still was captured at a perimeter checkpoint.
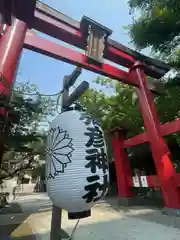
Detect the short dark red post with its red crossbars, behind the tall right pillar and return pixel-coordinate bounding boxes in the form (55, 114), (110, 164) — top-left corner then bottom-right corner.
(112, 119), (180, 197)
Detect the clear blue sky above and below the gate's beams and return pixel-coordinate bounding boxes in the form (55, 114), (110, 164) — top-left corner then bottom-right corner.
(17, 0), (146, 94)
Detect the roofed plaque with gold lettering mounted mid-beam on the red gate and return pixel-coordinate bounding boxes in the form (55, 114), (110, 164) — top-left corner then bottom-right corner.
(80, 16), (112, 64)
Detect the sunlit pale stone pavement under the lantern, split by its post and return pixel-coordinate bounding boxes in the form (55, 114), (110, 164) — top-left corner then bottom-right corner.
(14, 194), (180, 240)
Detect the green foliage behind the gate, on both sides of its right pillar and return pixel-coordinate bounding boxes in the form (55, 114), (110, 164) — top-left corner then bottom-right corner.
(79, 77), (180, 172)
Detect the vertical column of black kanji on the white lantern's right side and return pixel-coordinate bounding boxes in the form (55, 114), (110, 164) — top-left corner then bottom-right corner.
(80, 113), (108, 203)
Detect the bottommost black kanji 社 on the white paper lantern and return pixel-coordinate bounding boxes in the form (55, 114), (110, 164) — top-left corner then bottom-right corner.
(83, 175), (108, 203)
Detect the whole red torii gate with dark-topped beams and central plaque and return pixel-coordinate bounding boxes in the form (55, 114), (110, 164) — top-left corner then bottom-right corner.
(0, 0), (180, 216)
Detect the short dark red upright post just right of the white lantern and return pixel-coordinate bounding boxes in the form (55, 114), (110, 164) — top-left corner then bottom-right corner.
(111, 129), (133, 200)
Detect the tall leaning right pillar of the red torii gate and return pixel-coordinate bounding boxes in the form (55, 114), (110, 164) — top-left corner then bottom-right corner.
(129, 62), (180, 209)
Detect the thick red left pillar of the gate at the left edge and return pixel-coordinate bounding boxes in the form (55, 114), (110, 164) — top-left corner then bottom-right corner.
(0, 19), (27, 164)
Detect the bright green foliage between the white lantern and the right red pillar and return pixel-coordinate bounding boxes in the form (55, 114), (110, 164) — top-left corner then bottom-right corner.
(79, 77), (143, 136)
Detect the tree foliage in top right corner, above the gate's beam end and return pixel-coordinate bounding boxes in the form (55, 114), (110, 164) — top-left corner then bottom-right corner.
(129, 0), (180, 67)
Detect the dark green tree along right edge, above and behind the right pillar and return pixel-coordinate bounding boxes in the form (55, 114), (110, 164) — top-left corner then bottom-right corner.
(126, 0), (180, 172)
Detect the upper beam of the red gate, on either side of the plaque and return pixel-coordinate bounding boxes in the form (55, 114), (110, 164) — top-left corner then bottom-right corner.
(34, 2), (170, 78)
